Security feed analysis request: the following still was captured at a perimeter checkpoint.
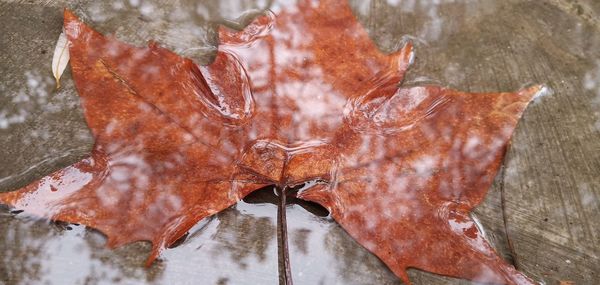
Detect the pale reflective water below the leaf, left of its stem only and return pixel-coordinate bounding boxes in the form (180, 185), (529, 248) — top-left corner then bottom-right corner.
(0, 202), (278, 284)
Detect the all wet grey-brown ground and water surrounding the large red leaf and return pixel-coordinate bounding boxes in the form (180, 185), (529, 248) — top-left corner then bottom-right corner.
(0, 1), (598, 284)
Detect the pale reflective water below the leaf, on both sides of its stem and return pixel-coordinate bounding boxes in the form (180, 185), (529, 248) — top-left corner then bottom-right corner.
(0, 195), (408, 284)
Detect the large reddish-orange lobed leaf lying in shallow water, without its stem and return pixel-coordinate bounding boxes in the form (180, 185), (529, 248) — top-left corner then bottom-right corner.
(0, 1), (541, 284)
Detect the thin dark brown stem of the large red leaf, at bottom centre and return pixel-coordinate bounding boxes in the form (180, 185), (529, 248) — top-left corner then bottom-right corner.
(275, 187), (294, 285)
